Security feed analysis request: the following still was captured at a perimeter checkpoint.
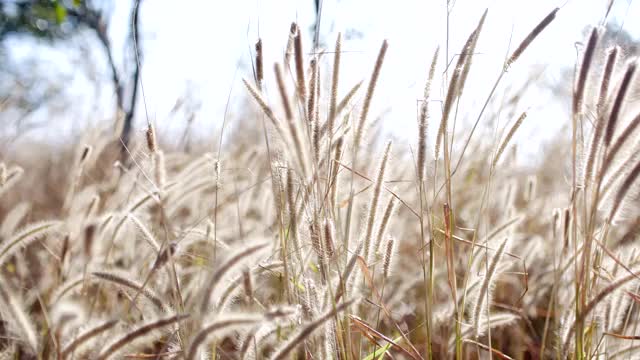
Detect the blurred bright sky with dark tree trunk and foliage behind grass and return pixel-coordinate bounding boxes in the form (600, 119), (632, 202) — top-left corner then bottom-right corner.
(0, 0), (640, 158)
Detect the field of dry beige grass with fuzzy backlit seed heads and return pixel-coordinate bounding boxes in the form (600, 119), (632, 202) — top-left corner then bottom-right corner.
(0, 9), (640, 359)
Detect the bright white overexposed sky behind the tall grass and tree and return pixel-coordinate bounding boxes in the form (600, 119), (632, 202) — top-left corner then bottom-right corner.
(5, 0), (640, 155)
